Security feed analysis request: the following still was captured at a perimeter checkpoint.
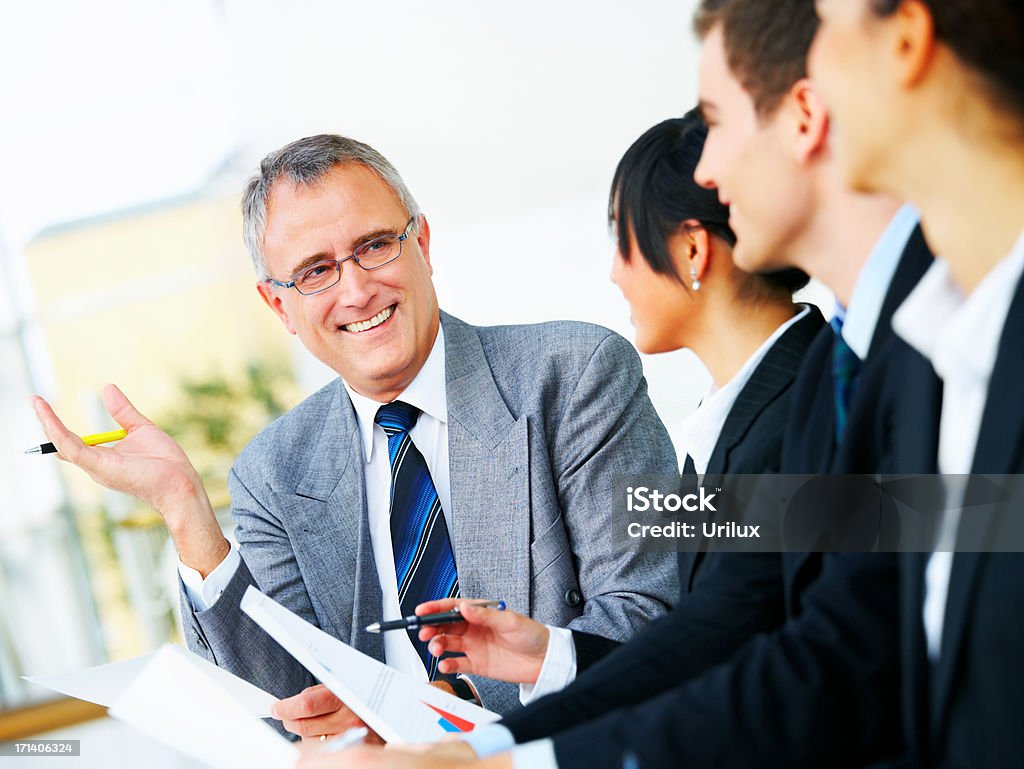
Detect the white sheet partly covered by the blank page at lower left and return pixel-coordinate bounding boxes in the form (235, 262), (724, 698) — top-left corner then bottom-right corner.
(25, 646), (278, 718)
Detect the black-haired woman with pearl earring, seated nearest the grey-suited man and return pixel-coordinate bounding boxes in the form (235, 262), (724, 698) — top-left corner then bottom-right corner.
(407, 112), (823, 712)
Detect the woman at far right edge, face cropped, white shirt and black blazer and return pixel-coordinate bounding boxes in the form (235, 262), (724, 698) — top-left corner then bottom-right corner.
(810, 0), (1024, 767)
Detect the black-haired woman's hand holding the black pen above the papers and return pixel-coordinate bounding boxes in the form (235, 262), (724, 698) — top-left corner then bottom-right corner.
(416, 598), (550, 683)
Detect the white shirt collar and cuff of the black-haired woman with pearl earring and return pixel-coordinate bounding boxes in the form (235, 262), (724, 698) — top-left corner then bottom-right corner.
(519, 307), (811, 704)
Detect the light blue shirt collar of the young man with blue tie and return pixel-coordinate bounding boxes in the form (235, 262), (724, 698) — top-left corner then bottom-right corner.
(836, 205), (921, 360)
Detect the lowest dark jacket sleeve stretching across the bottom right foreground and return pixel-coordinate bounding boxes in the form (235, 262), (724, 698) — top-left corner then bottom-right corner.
(548, 554), (900, 769)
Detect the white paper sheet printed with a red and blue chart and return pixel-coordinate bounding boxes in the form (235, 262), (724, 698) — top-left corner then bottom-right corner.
(236, 586), (500, 742)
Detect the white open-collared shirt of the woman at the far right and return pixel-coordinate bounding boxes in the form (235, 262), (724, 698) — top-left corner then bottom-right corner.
(893, 228), (1024, 661)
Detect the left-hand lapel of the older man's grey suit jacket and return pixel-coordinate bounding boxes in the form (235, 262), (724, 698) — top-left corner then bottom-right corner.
(278, 380), (384, 659)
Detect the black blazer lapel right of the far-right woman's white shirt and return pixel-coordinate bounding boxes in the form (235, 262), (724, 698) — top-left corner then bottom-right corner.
(933, 279), (1024, 733)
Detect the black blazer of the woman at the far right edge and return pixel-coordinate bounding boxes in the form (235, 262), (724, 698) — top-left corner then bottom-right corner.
(895, 268), (1024, 769)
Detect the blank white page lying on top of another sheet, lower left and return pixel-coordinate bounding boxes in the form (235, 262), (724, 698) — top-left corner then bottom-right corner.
(110, 646), (299, 769)
